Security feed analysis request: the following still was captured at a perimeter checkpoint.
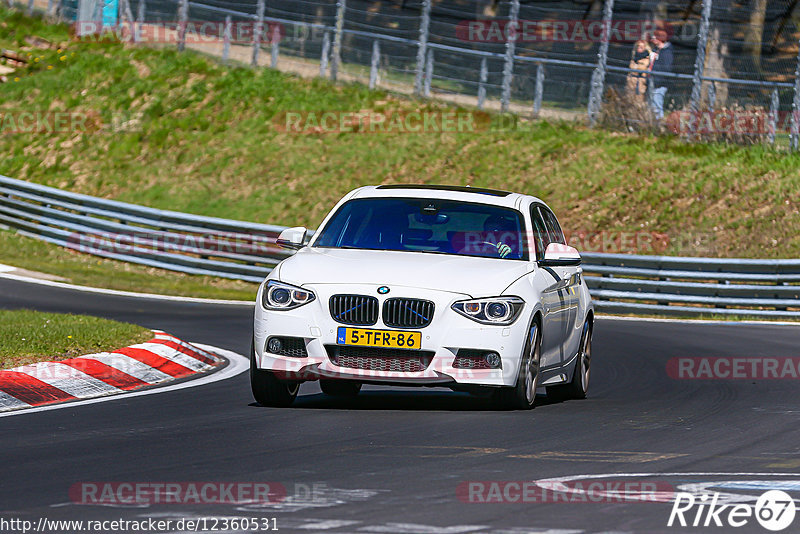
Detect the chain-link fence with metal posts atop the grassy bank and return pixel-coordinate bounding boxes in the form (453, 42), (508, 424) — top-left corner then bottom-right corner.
(18, 0), (800, 150)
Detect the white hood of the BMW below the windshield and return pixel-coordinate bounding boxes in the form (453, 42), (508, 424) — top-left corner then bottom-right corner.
(277, 247), (531, 298)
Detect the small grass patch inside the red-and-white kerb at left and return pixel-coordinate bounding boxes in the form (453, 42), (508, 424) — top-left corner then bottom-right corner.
(0, 310), (153, 369)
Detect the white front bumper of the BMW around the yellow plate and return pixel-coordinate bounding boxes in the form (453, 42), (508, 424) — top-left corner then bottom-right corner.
(254, 284), (530, 386)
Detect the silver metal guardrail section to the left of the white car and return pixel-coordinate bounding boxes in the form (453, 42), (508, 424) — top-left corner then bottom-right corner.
(0, 176), (288, 282)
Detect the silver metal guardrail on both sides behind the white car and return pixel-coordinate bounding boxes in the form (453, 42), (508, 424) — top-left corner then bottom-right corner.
(0, 176), (800, 319)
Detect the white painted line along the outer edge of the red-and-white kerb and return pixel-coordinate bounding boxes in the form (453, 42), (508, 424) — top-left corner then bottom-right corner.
(0, 343), (250, 418)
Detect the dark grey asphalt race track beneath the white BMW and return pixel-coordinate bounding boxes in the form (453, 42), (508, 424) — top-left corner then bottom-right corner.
(0, 280), (800, 534)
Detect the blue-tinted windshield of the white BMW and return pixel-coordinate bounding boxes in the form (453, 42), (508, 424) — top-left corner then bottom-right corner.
(314, 198), (528, 260)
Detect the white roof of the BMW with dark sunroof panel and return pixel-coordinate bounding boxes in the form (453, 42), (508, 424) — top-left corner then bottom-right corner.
(350, 184), (541, 208)
